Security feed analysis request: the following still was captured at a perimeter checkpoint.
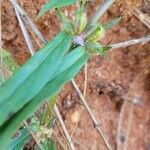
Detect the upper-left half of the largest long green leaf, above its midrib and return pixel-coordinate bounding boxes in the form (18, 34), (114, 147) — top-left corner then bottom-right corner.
(0, 33), (65, 103)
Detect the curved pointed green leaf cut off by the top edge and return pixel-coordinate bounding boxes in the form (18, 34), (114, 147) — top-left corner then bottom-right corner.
(37, 0), (76, 18)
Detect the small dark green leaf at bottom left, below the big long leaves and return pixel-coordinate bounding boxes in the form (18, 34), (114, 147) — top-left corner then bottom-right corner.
(7, 128), (31, 150)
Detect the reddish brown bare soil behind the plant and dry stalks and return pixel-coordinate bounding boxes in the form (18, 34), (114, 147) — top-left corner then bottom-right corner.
(2, 0), (150, 150)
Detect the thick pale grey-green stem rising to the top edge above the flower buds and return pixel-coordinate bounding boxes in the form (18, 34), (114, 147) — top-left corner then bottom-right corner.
(85, 0), (115, 32)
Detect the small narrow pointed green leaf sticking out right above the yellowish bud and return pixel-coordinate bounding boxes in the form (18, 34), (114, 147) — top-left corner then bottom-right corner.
(103, 17), (122, 30)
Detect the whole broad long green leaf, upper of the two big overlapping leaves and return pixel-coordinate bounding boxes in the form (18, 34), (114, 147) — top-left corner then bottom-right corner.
(0, 32), (71, 126)
